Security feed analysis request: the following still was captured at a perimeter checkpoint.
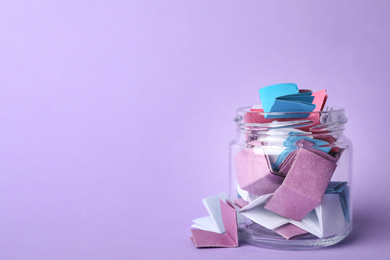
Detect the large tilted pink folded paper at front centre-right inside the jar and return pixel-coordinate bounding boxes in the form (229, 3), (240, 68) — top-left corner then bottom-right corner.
(264, 148), (336, 220)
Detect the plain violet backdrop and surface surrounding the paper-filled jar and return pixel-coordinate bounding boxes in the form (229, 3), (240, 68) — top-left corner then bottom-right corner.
(0, 0), (390, 259)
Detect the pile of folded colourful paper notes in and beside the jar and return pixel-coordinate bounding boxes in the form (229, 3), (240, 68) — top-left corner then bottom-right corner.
(191, 83), (350, 247)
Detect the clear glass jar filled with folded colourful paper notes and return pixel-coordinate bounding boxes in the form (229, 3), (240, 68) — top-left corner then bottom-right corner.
(230, 107), (352, 249)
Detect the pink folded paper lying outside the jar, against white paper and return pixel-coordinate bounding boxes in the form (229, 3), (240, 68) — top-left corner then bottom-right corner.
(190, 200), (238, 247)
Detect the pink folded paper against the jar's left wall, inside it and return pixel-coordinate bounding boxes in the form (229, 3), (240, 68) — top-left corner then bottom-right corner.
(234, 149), (283, 196)
